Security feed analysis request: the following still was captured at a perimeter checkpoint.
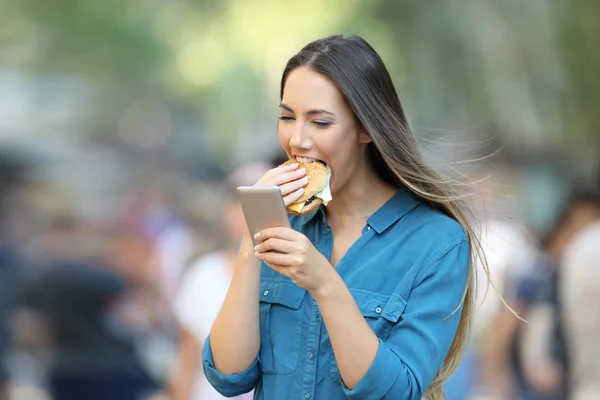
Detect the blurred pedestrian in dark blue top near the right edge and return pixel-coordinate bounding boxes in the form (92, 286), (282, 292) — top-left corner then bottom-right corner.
(513, 185), (600, 400)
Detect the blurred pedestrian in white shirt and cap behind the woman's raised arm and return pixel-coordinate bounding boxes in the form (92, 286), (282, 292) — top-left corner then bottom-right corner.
(170, 163), (271, 400)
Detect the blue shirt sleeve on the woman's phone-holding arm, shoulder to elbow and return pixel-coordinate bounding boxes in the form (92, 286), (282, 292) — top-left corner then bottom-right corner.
(342, 241), (470, 400)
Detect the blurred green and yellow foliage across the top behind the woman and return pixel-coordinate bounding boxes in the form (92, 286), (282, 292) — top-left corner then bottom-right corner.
(0, 0), (600, 170)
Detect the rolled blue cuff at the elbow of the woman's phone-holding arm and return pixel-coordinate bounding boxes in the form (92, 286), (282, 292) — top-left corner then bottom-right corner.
(342, 339), (400, 400)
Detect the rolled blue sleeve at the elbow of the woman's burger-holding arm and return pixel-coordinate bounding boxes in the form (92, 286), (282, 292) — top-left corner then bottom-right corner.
(202, 335), (260, 397)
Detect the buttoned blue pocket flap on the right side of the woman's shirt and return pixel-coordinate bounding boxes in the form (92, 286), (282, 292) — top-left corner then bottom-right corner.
(350, 289), (406, 323)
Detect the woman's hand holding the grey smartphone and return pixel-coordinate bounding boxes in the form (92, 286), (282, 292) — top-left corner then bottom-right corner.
(255, 227), (334, 293)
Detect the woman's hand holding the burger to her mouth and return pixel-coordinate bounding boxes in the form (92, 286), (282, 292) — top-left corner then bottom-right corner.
(254, 163), (308, 207)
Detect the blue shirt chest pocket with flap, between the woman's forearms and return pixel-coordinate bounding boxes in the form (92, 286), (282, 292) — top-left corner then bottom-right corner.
(260, 278), (306, 375)
